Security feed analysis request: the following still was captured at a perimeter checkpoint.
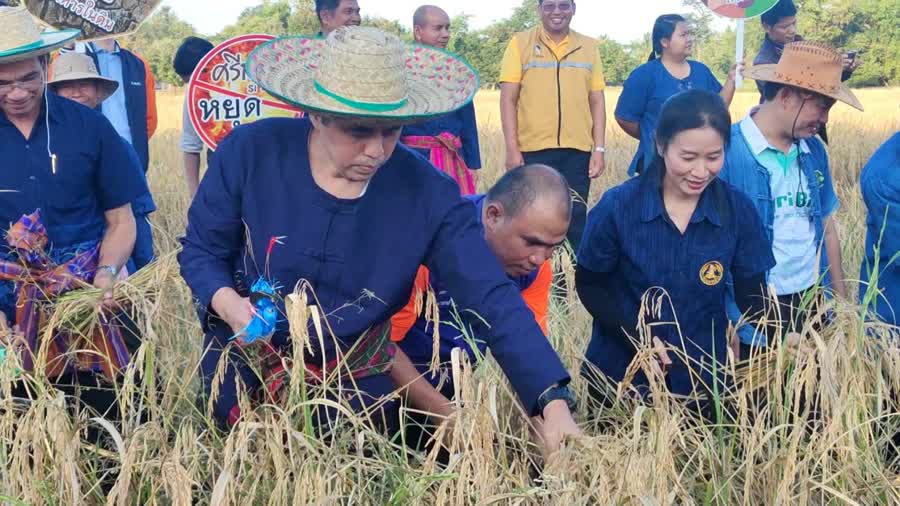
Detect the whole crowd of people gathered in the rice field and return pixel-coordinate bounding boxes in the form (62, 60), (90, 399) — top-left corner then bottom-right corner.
(0, 0), (900, 460)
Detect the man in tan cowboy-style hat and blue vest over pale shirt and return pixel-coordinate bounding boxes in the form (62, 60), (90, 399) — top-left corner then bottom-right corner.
(720, 41), (863, 355)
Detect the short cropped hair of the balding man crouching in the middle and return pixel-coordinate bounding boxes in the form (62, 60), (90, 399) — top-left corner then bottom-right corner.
(486, 164), (572, 217)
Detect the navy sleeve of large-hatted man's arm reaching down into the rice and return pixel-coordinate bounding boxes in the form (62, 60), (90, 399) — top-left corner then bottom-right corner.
(427, 190), (570, 416)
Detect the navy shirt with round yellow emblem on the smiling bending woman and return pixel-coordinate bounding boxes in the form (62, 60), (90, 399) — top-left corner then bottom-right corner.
(578, 176), (775, 394)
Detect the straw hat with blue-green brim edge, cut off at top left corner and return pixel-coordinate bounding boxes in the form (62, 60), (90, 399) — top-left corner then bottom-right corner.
(0, 6), (81, 63)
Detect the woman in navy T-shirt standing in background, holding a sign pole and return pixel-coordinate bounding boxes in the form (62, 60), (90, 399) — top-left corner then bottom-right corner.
(616, 14), (737, 176)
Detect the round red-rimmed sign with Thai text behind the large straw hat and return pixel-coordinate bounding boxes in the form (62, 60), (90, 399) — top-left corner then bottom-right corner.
(188, 34), (302, 150)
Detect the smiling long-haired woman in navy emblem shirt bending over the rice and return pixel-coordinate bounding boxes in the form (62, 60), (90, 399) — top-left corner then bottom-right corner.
(576, 90), (775, 414)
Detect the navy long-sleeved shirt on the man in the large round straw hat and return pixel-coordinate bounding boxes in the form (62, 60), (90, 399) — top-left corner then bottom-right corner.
(179, 119), (569, 409)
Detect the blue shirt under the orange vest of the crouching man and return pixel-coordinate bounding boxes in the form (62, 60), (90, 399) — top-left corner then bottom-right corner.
(399, 195), (538, 370)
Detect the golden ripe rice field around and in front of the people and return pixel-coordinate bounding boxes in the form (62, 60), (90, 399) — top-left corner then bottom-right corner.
(0, 89), (900, 506)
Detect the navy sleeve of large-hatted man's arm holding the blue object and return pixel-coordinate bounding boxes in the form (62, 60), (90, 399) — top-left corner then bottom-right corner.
(178, 132), (245, 320)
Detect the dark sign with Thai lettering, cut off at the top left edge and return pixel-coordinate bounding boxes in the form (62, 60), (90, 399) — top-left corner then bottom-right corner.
(22, 0), (162, 41)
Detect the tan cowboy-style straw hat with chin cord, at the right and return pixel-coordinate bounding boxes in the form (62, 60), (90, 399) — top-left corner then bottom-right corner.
(746, 41), (863, 111)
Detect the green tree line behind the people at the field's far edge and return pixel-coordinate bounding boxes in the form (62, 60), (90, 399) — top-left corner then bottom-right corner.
(126, 0), (900, 86)
